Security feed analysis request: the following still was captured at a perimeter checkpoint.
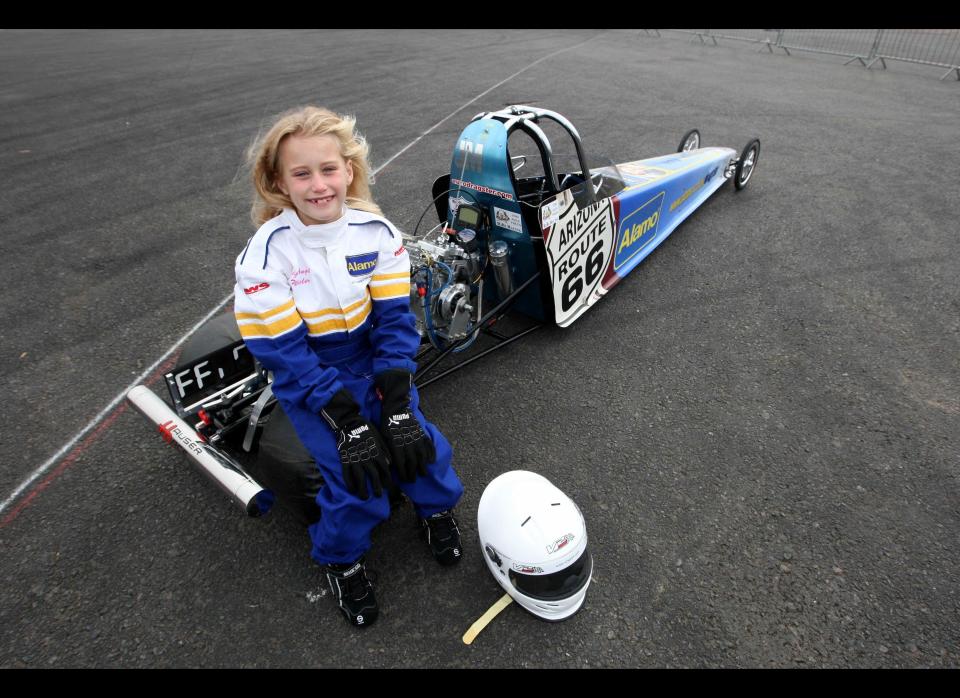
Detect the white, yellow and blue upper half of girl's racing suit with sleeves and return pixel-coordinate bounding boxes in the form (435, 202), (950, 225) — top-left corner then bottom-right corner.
(235, 209), (420, 413)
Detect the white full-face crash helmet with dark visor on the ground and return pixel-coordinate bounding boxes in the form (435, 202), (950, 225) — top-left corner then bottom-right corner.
(477, 470), (593, 620)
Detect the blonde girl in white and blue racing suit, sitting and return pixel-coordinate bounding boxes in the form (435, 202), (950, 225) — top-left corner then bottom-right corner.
(235, 107), (463, 626)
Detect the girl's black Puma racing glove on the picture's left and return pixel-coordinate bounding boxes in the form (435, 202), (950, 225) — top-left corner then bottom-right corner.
(320, 389), (390, 499)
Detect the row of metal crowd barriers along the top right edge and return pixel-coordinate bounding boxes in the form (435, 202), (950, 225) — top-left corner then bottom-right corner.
(643, 29), (960, 80)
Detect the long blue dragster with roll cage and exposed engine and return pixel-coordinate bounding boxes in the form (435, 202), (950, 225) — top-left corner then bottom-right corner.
(127, 105), (760, 524)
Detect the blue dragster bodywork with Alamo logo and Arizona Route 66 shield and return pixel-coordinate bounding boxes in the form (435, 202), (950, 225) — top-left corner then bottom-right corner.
(447, 111), (738, 327)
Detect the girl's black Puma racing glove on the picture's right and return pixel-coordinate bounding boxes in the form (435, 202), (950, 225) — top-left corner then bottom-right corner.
(375, 369), (437, 482)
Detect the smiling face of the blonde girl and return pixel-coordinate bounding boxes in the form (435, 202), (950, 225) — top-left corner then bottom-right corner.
(277, 135), (353, 225)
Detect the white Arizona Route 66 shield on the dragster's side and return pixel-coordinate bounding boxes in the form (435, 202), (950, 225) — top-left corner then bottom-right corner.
(544, 190), (616, 327)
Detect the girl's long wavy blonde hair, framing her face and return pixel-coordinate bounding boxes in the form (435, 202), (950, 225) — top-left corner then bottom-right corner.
(247, 106), (383, 227)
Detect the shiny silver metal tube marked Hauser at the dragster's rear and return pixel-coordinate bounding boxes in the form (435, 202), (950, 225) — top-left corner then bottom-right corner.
(127, 385), (274, 516)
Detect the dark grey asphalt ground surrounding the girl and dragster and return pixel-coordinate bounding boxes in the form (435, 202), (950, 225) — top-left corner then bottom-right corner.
(0, 30), (960, 668)
